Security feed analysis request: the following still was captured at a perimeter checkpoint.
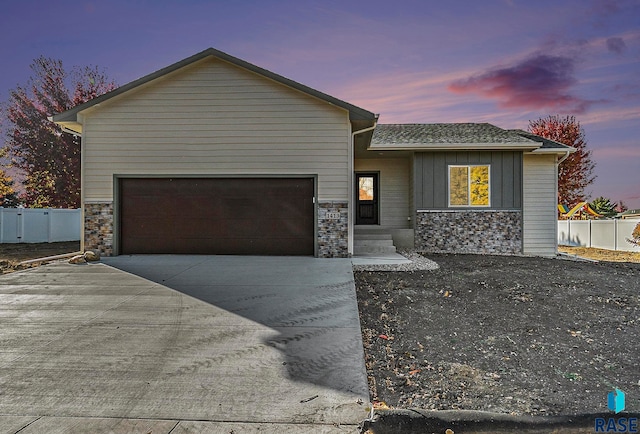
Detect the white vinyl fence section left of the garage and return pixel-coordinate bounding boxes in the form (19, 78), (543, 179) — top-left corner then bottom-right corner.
(0, 207), (81, 243)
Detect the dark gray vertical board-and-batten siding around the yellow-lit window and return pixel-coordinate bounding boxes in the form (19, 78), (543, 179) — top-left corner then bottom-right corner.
(413, 151), (522, 210)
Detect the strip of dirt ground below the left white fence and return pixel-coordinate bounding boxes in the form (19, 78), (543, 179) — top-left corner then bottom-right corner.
(0, 241), (80, 273)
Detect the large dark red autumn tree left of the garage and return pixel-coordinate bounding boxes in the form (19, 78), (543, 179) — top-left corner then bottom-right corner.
(3, 56), (116, 208)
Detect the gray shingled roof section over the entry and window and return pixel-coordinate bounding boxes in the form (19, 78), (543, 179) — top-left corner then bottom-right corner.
(369, 123), (541, 150)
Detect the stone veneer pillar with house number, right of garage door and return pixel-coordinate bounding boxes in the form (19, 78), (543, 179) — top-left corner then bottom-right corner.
(318, 201), (349, 258)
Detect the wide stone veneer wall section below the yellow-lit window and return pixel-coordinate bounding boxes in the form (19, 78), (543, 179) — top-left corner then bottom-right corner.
(415, 210), (522, 255)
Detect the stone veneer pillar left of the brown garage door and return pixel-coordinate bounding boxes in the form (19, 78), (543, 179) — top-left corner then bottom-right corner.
(84, 202), (113, 256)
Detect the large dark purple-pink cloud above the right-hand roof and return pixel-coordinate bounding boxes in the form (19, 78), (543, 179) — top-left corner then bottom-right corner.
(448, 54), (592, 114)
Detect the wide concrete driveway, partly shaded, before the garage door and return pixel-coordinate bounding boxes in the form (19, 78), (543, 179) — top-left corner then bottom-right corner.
(0, 255), (368, 434)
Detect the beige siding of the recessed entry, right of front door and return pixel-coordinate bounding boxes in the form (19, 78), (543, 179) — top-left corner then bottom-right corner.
(354, 158), (413, 229)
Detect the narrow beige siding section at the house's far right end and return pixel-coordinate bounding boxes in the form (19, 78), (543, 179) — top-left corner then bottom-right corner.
(522, 154), (558, 256)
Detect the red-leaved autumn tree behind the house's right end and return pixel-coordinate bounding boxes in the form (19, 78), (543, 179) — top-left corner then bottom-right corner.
(529, 115), (596, 207)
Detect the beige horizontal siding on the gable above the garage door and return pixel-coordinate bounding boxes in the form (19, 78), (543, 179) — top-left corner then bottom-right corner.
(82, 58), (351, 202)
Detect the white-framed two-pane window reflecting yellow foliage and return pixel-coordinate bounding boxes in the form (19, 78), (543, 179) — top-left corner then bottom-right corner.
(449, 165), (489, 206)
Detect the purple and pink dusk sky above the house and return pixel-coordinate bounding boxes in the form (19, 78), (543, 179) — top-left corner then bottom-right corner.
(0, 0), (640, 208)
